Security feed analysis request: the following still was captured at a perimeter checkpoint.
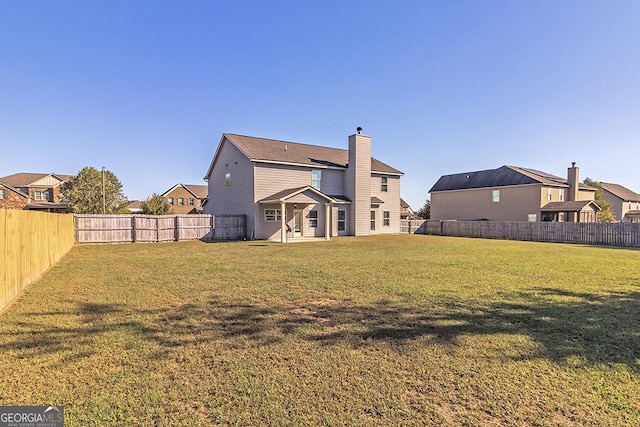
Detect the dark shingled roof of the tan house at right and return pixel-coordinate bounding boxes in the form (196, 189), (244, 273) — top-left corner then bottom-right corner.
(429, 166), (595, 193)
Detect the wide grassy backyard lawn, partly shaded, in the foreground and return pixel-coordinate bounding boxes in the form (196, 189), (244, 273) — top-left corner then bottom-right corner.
(0, 236), (640, 426)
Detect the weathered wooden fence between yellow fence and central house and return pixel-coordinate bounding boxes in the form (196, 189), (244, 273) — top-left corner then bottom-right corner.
(75, 215), (246, 243)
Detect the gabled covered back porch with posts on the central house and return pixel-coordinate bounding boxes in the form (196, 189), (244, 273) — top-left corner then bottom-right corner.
(258, 186), (336, 243)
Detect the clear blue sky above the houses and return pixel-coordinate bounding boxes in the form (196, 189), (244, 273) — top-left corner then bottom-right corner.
(0, 0), (640, 209)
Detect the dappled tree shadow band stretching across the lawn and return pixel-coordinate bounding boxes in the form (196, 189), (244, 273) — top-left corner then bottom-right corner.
(0, 289), (640, 372)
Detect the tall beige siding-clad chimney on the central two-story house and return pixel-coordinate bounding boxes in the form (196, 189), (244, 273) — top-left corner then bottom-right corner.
(345, 127), (371, 236)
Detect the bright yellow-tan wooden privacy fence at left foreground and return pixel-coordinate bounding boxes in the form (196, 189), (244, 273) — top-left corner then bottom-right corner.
(0, 209), (74, 310)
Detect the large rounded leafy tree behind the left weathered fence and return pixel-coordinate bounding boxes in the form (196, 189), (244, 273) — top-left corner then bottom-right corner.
(60, 166), (129, 214)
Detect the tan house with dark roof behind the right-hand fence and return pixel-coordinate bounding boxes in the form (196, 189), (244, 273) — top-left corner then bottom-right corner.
(429, 163), (600, 222)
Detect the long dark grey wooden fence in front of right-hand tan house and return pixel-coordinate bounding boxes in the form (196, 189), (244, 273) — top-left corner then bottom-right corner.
(425, 220), (640, 248)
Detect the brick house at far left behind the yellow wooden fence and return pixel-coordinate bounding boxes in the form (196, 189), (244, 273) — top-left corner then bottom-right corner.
(0, 173), (72, 213)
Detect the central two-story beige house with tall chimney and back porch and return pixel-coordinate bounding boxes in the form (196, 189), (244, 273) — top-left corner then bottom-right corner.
(205, 128), (403, 242)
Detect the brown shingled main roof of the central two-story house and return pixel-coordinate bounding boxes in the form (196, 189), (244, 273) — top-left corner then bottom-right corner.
(218, 133), (403, 175)
